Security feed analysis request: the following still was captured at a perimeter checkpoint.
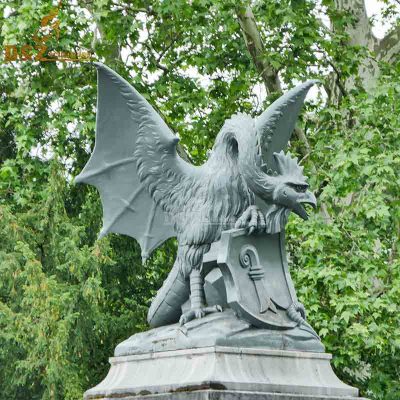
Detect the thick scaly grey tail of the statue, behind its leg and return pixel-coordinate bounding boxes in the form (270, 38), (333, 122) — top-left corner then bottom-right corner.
(147, 257), (190, 328)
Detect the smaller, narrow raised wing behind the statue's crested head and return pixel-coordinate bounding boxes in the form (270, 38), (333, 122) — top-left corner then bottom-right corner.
(256, 80), (318, 171)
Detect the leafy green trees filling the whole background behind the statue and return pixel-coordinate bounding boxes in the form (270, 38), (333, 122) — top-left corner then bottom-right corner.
(0, 0), (400, 400)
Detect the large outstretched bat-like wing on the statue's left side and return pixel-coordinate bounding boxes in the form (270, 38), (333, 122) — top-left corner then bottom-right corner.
(75, 63), (198, 259)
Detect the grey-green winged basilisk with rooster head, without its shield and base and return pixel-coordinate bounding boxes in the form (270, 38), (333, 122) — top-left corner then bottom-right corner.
(76, 63), (316, 327)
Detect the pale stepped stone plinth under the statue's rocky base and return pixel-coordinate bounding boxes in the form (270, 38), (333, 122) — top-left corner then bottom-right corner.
(85, 346), (360, 400)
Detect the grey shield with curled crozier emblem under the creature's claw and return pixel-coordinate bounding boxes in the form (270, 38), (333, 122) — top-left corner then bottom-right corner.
(206, 229), (317, 336)
